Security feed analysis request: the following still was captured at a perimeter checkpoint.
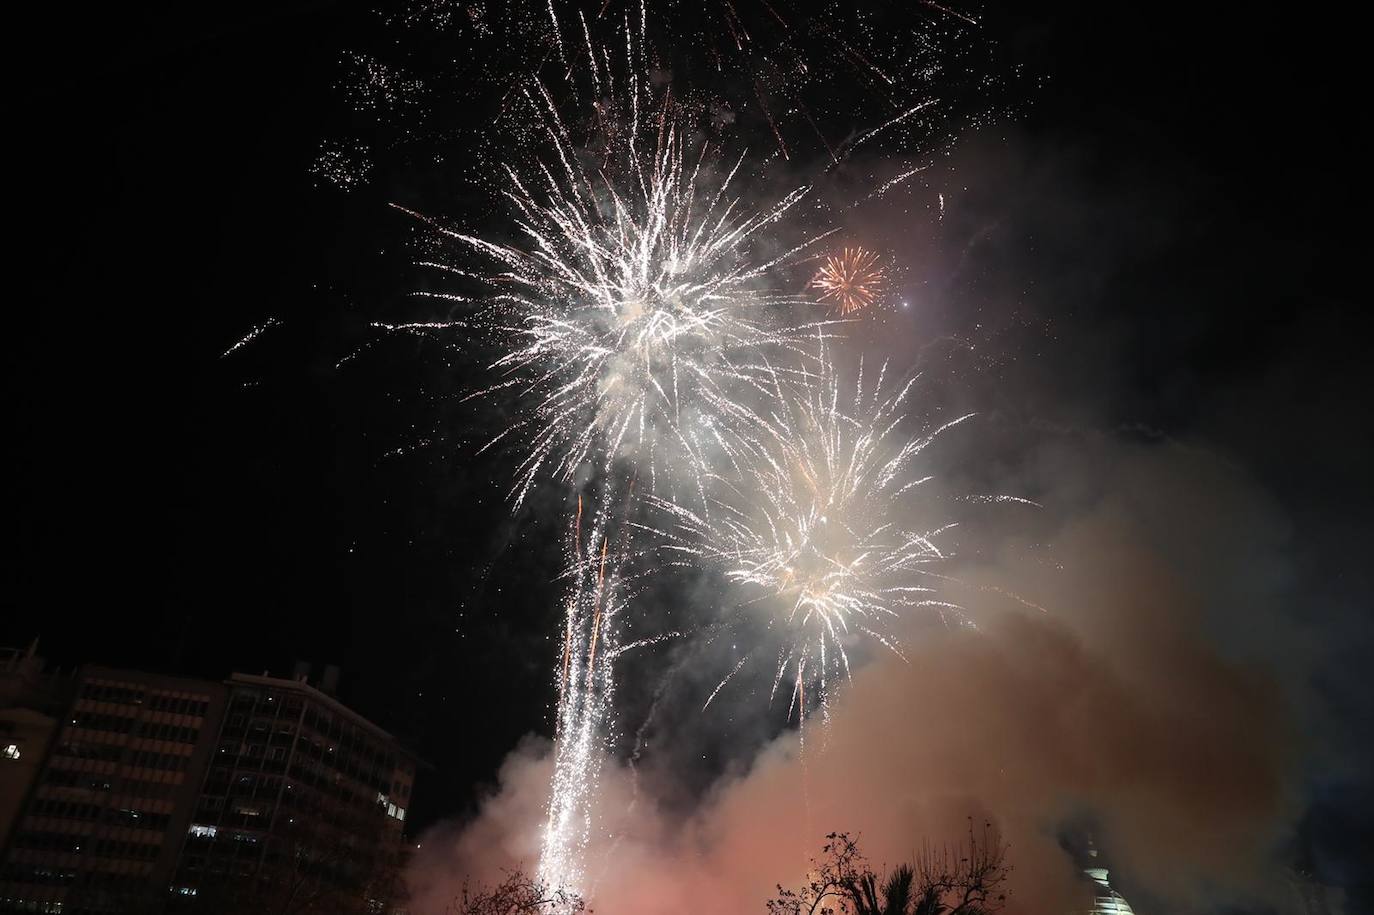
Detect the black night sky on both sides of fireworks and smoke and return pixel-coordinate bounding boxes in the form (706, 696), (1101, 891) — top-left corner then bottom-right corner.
(0, 3), (1374, 882)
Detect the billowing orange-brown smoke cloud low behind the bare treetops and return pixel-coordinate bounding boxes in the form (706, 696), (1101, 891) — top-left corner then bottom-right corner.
(411, 434), (1301, 915)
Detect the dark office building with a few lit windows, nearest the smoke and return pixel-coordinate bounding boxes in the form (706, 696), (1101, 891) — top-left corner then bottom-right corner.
(172, 675), (415, 914)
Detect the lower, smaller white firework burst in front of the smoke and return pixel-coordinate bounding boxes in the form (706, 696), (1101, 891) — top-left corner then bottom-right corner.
(651, 353), (969, 713)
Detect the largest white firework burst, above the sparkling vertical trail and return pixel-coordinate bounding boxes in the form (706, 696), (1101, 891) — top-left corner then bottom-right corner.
(401, 84), (824, 506)
